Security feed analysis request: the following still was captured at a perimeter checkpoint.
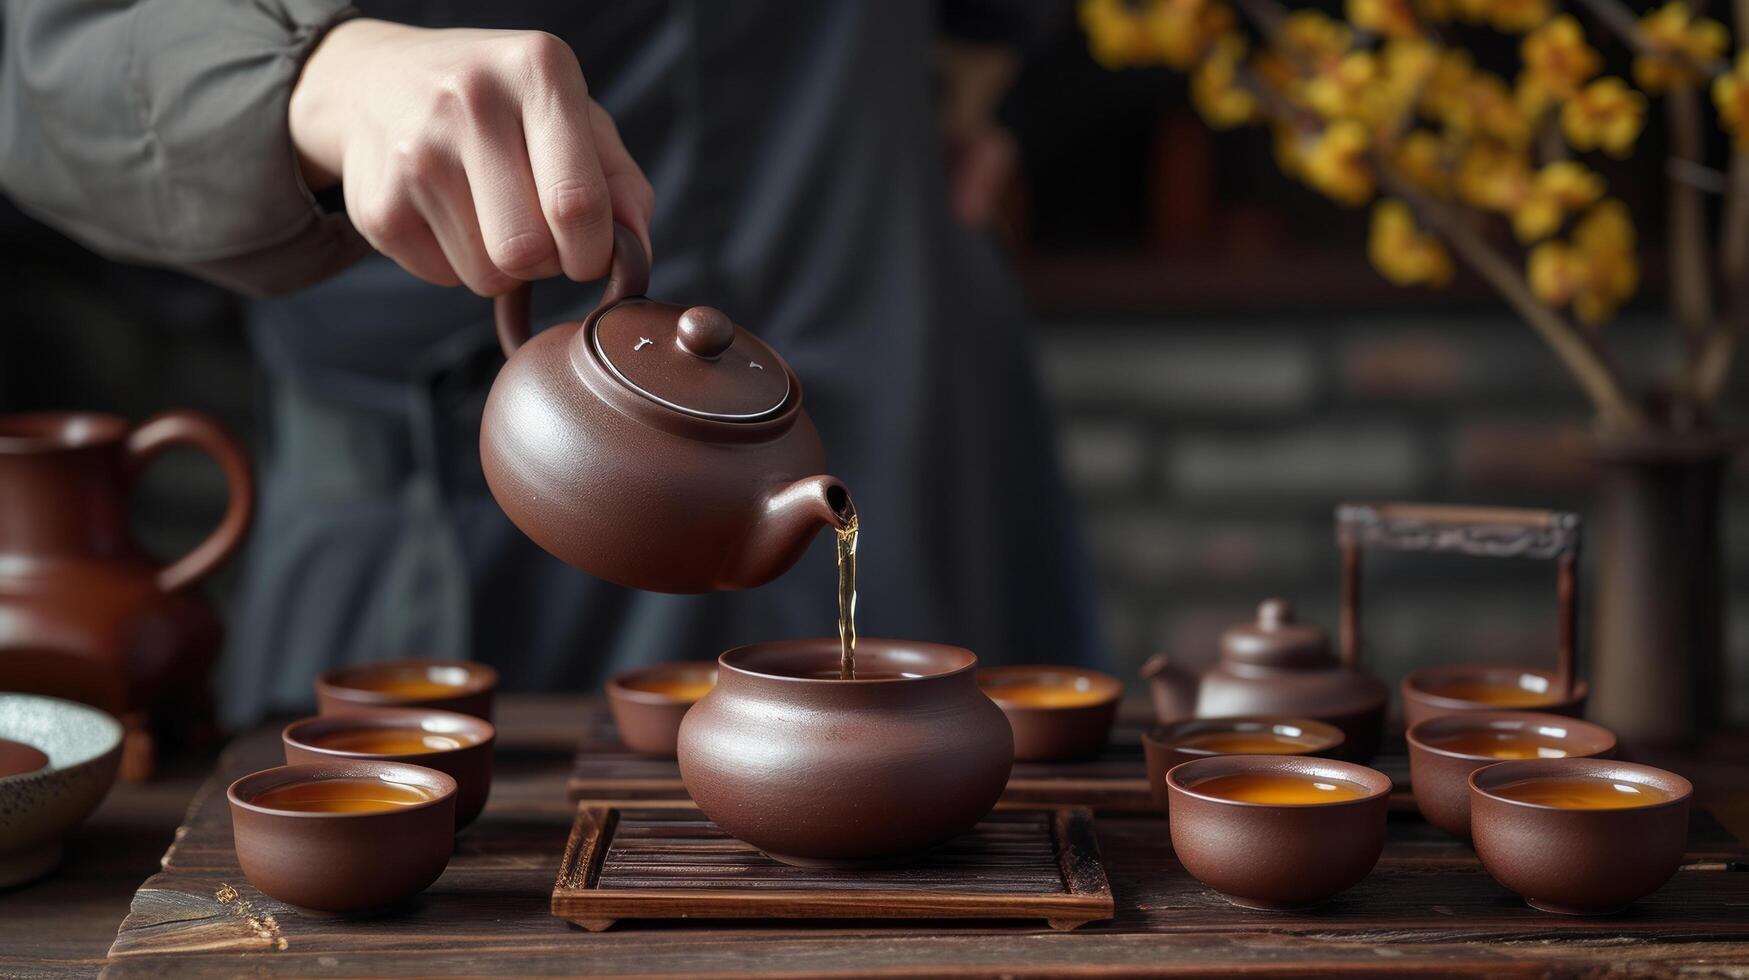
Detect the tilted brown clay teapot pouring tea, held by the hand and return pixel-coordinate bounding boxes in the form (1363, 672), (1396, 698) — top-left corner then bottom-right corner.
(479, 226), (855, 593)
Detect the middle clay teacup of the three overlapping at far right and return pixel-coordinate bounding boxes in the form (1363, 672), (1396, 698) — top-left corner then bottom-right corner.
(1406, 711), (1616, 838)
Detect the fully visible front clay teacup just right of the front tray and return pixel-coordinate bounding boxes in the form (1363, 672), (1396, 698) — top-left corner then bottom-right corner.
(1167, 756), (1390, 912)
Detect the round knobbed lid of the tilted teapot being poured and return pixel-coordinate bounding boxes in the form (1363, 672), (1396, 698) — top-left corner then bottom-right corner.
(589, 298), (791, 422)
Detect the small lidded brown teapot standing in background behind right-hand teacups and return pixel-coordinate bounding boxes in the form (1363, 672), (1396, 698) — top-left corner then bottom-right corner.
(1142, 599), (1389, 761)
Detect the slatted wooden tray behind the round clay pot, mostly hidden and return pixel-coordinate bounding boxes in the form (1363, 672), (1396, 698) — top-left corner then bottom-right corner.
(565, 698), (1415, 814)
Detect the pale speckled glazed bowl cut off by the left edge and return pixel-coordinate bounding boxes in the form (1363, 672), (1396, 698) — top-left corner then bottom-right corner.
(0, 693), (122, 887)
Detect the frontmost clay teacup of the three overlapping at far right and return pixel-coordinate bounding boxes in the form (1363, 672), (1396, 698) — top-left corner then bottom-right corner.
(1469, 760), (1695, 915)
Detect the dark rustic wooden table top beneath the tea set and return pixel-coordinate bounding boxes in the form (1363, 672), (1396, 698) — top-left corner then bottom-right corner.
(10, 698), (1749, 978)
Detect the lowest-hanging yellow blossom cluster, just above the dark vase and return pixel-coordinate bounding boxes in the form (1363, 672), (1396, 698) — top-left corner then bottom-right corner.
(1527, 200), (1639, 324)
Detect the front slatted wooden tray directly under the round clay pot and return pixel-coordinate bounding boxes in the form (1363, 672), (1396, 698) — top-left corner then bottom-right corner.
(553, 800), (1112, 933)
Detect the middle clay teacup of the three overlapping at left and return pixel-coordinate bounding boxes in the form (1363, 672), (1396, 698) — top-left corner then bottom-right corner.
(280, 707), (497, 831)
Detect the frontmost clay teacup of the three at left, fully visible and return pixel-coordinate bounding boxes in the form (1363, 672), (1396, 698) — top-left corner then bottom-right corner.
(226, 760), (456, 912)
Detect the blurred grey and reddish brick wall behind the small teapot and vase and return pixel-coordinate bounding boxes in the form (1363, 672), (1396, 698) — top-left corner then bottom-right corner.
(1041, 312), (1749, 719)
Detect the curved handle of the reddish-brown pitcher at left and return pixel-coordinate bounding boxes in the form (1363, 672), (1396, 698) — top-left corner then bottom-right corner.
(126, 410), (255, 592)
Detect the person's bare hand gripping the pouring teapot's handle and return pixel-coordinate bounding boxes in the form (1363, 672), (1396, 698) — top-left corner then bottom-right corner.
(290, 19), (654, 296)
